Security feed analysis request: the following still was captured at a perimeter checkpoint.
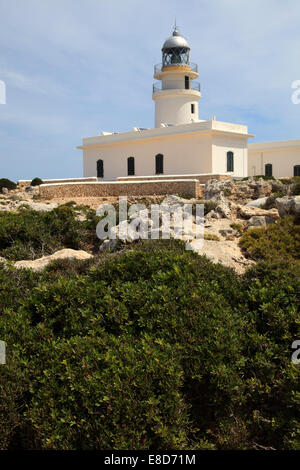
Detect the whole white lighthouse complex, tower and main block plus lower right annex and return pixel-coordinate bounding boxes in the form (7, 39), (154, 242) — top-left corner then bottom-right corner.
(78, 26), (300, 180)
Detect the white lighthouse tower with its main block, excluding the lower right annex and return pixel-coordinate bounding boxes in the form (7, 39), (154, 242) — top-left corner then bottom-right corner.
(78, 24), (253, 182)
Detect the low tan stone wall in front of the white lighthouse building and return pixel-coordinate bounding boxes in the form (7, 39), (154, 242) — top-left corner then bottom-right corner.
(40, 179), (204, 199)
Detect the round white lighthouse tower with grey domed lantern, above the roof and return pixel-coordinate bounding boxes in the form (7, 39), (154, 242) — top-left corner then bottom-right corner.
(152, 24), (201, 127)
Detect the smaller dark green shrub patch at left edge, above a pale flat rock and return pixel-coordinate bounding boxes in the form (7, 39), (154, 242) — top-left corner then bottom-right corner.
(0, 204), (100, 261)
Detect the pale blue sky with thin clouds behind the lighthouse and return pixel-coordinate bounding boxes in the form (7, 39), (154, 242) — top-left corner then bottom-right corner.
(0, 0), (300, 181)
